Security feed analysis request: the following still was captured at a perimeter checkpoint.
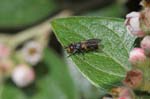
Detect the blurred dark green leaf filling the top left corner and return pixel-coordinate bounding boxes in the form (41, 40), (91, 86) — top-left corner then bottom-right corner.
(0, 0), (59, 28)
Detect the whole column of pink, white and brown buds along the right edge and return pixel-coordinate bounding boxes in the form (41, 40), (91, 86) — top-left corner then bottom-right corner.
(124, 0), (150, 92)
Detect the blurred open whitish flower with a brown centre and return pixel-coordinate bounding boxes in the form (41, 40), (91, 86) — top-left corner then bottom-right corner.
(22, 41), (43, 65)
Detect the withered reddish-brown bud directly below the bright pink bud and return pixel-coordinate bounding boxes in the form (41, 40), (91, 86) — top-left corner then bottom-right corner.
(123, 70), (143, 89)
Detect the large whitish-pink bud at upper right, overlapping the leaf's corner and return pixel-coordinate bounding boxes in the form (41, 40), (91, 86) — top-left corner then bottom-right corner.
(125, 12), (145, 37)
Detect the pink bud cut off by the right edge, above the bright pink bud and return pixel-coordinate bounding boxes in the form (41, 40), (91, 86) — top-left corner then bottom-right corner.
(141, 36), (150, 56)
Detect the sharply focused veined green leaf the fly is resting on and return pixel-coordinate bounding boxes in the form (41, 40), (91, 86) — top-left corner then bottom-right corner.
(52, 17), (135, 88)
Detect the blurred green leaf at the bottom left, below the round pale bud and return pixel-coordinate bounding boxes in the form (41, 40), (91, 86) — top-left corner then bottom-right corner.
(0, 49), (78, 99)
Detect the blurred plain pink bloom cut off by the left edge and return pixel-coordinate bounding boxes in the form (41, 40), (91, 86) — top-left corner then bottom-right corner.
(0, 43), (10, 59)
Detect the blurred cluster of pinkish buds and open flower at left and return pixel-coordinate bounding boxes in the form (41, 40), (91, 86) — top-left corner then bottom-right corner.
(0, 41), (43, 87)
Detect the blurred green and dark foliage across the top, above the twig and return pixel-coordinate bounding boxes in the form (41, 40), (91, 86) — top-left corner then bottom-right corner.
(0, 0), (140, 32)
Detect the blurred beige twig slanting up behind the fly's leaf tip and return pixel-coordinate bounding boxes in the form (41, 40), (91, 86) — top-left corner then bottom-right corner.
(9, 10), (72, 49)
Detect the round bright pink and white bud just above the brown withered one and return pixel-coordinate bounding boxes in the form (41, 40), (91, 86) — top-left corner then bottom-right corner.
(129, 48), (146, 65)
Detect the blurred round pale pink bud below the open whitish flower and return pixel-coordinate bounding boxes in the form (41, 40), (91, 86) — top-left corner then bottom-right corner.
(12, 64), (35, 87)
